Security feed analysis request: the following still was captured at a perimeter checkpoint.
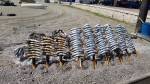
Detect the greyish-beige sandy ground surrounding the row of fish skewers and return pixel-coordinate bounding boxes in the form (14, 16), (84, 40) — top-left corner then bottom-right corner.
(0, 4), (150, 84)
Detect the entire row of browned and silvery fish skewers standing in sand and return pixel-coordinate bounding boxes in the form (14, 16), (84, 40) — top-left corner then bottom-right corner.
(15, 24), (137, 69)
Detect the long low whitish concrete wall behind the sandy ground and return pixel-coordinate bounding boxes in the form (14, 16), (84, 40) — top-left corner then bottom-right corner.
(72, 3), (150, 23)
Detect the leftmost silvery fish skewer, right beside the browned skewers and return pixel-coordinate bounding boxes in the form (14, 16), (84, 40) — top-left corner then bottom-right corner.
(70, 28), (84, 68)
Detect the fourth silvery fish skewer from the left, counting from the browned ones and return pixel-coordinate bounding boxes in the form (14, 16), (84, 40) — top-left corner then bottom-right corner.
(104, 24), (122, 64)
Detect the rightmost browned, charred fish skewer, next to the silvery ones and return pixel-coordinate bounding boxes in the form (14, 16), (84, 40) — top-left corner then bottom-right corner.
(53, 29), (71, 67)
